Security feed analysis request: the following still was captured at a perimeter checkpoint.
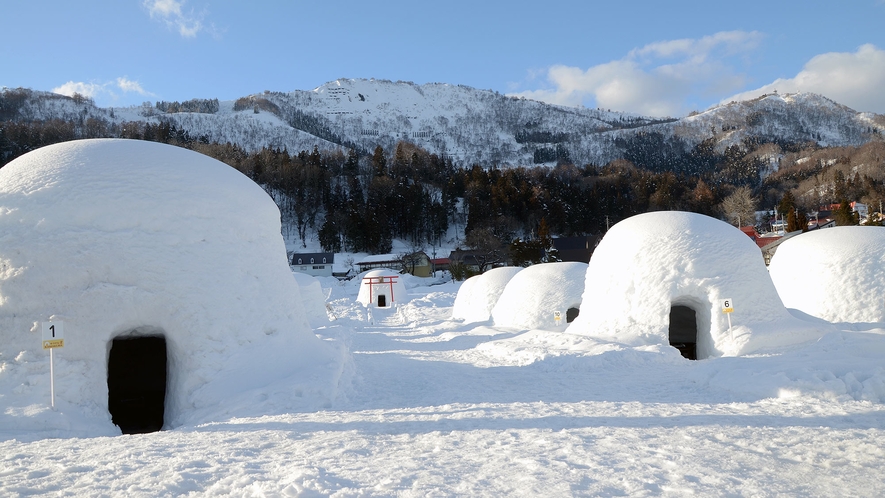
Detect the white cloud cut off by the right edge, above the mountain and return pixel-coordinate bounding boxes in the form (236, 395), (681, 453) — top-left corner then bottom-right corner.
(723, 44), (885, 113)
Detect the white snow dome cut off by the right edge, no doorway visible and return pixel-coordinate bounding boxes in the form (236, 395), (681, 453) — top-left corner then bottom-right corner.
(768, 226), (885, 323)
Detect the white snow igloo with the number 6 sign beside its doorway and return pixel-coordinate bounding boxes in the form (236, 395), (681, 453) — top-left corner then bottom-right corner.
(567, 211), (820, 359)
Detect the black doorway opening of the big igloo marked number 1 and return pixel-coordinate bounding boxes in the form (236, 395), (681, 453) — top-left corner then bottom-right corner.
(108, 336), (166, 434)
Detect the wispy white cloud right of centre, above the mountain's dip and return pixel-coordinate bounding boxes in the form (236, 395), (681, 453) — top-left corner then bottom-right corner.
(514, 31), (763, 116)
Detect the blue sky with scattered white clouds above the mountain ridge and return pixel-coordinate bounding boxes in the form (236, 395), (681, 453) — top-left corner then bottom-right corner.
(0, 0), (885, 116)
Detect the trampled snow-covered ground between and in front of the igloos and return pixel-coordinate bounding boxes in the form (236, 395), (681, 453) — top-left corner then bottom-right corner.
(0, 279), (885, 496)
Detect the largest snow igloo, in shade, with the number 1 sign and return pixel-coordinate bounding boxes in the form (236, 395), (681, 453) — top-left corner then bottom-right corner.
(0, 139), (344, 433)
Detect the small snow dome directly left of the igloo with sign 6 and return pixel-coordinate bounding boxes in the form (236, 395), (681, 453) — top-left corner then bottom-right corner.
(492, 262), (587, 331)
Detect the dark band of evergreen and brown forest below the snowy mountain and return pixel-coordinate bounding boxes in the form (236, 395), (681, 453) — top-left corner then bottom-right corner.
(0, 114), (885, 254)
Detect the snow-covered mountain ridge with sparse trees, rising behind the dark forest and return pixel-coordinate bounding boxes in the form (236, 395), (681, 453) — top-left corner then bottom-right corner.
(0, 79), (885, 169)
